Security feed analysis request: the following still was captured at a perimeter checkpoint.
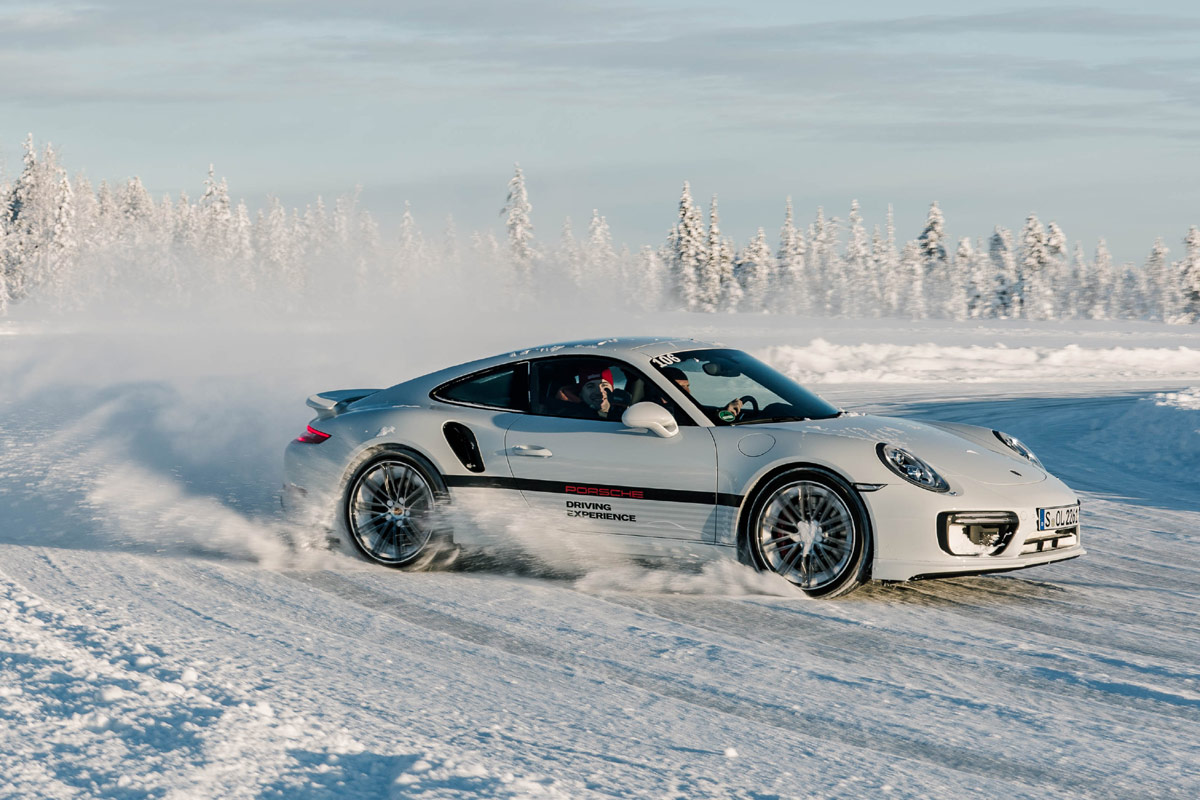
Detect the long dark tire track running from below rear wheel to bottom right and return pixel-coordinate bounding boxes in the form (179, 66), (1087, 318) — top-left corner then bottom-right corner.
(283, 571), (1133, 799)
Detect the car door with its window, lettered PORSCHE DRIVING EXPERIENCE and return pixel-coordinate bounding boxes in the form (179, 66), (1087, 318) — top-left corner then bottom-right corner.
(505, 356), (716, 542)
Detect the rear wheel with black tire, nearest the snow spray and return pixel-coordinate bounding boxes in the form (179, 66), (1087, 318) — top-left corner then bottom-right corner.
(338, 449), (456, 570)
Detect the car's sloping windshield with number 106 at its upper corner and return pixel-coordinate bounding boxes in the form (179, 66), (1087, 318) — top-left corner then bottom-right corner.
(650, 350), (840, 425)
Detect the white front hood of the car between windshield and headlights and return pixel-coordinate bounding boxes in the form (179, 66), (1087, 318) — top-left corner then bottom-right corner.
(744, 415), (1046, 486)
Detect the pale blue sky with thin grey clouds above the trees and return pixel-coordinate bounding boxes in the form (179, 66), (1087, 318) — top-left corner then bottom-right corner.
(0, 0), (1200, 260)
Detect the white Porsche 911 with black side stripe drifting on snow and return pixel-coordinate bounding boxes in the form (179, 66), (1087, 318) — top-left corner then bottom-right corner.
(284, 338), (1084, 597)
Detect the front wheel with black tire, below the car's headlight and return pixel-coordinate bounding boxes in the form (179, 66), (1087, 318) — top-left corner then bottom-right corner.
(739, 468), (871, 597)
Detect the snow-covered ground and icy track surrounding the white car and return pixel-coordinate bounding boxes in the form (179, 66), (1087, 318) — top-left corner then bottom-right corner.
(0, 315), (1200, 800)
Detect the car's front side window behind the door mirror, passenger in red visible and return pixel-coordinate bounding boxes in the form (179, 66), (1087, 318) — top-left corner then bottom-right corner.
(529, 356), (694, 425)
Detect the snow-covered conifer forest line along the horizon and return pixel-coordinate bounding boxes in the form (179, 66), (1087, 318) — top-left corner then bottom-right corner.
(0, 137), (1200, 323)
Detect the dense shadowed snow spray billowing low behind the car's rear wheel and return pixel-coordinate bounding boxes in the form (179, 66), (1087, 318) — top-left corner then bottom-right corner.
(0, 364), (322, 567)
